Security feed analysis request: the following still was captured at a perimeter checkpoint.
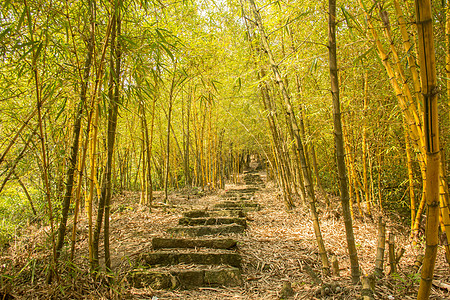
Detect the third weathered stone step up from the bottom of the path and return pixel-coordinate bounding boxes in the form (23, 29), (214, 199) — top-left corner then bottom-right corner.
(152, 238), (237, 249)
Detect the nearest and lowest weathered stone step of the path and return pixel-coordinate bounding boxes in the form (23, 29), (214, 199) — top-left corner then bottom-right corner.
(127, 266), (243, 290)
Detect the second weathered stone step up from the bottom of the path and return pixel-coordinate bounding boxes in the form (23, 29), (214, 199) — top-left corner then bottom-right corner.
(140, 250), (241, 268)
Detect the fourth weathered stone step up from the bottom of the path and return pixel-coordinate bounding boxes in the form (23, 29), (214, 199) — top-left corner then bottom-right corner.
(167, 224), (245, 236)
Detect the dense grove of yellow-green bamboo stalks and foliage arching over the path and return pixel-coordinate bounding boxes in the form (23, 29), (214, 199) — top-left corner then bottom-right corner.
(0, 0), (450, 297)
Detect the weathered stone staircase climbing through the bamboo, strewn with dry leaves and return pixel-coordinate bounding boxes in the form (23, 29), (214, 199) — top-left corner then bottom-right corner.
(127, 173), (264, 290)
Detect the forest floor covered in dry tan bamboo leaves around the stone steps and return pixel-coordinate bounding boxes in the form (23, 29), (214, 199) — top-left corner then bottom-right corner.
(0, 172), (450, 300)
